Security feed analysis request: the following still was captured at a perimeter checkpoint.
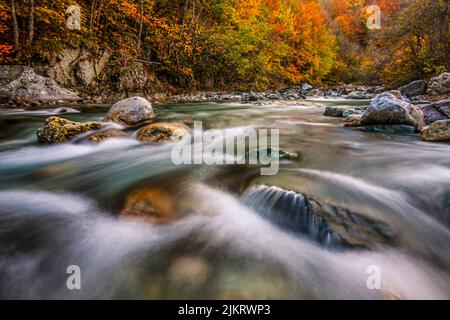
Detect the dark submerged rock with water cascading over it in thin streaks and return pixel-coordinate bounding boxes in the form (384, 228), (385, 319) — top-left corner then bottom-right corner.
(242, 185), (396, 248)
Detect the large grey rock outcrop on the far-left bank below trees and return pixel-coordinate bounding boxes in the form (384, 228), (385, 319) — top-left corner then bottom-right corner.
(0, 66), (80, 103)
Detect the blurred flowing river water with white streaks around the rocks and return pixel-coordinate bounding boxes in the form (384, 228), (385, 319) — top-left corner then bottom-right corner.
(0, 100), (450, 299)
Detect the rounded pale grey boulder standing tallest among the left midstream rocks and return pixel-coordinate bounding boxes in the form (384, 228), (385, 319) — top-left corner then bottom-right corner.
(104, 97), (155, 127)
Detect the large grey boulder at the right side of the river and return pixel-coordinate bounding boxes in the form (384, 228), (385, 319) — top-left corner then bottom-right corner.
(361, 92), (424, 129)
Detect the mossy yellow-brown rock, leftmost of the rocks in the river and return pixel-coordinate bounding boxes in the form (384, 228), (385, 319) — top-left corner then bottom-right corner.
(37, 117), (102, 144)
